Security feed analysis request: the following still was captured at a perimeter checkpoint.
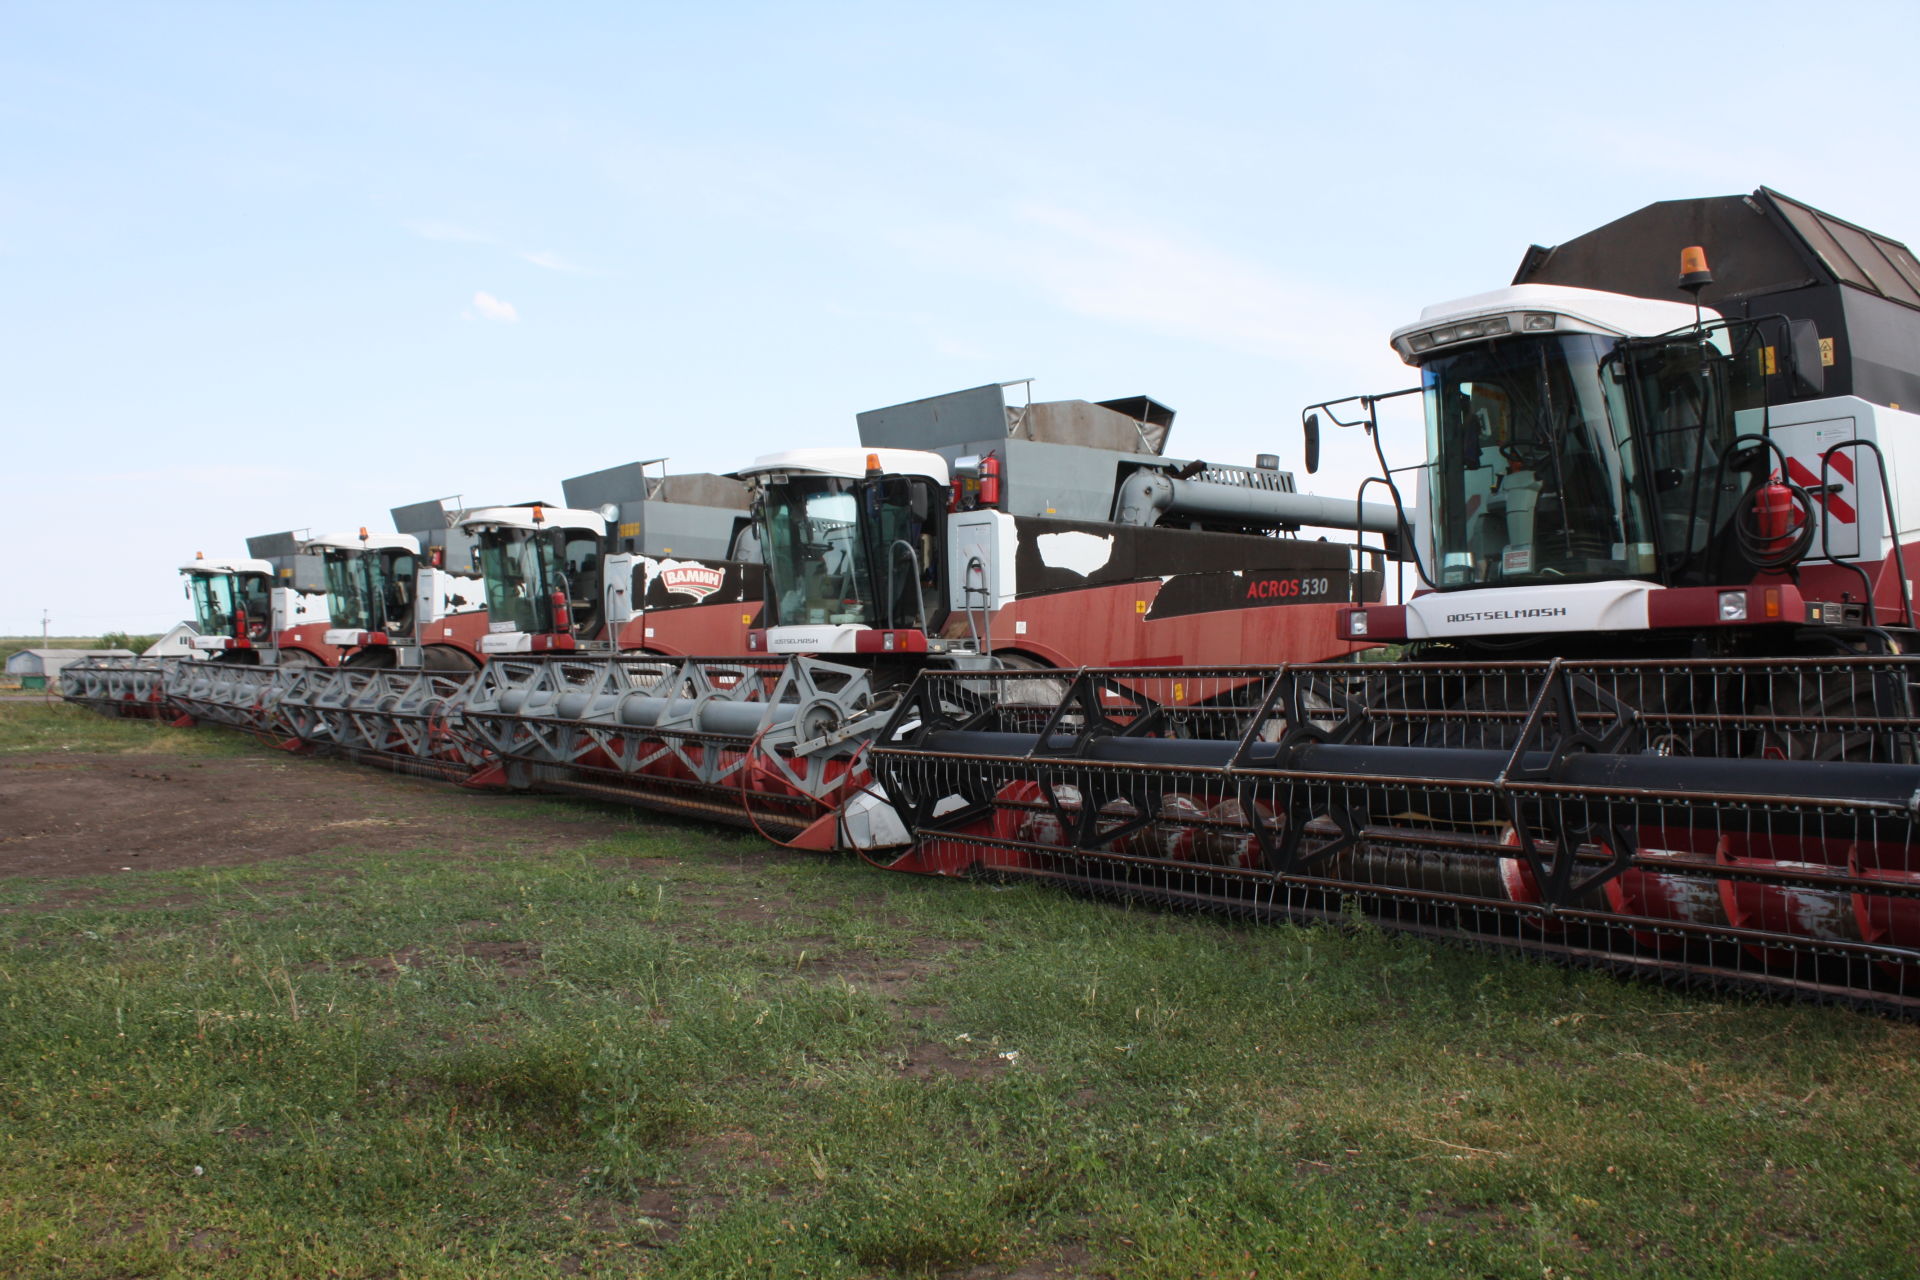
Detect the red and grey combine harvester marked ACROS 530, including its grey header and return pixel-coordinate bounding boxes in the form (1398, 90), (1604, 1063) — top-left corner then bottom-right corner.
(457, 386), (1398, 848)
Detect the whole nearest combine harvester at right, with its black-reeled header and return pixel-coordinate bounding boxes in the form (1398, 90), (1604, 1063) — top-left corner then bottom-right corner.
(868, 190), (1920, 1013)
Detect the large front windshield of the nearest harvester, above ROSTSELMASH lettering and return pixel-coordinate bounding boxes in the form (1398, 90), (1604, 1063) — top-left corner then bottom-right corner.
(1423, 334), (1657, 589)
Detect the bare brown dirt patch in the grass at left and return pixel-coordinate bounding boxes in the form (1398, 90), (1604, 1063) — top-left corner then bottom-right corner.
(0, 752), (632, 875)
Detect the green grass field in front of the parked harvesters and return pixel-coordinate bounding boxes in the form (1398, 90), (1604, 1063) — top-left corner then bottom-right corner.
(0, 704), (1920, 1278)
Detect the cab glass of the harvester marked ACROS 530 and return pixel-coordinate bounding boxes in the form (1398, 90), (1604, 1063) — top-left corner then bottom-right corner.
(760, 476), (941, 628)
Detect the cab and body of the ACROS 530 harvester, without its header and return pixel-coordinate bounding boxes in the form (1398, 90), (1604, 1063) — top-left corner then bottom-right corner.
(739, 384), (1400, 668)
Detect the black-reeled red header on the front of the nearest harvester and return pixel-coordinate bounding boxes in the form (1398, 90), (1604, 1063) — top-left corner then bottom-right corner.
(868, 658), (1920, 1013)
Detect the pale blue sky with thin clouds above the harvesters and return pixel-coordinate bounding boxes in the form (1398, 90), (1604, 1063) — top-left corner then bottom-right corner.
(0, 0), (1920, 633)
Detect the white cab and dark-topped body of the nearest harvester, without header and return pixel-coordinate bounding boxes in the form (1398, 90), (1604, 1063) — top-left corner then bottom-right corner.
(1336, 188), (1920, 656)
